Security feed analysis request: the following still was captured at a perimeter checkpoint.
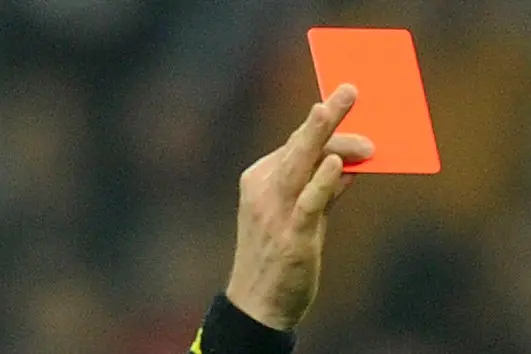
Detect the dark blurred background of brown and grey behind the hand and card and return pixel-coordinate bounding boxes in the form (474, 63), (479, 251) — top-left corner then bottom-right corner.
(0, 0), (531, 354)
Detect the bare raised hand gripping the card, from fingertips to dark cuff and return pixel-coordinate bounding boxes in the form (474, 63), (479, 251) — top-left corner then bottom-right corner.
(226, 84), (374, 330)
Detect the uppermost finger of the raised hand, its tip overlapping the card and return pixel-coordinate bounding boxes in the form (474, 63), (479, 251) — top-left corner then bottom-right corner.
(279, 84), (357, 194)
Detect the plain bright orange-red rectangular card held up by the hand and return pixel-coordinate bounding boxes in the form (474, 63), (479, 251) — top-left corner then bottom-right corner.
(308, 28), (441, 174)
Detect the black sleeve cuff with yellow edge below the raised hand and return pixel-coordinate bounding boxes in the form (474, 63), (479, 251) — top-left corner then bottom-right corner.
(189, 294), (295, 354)
